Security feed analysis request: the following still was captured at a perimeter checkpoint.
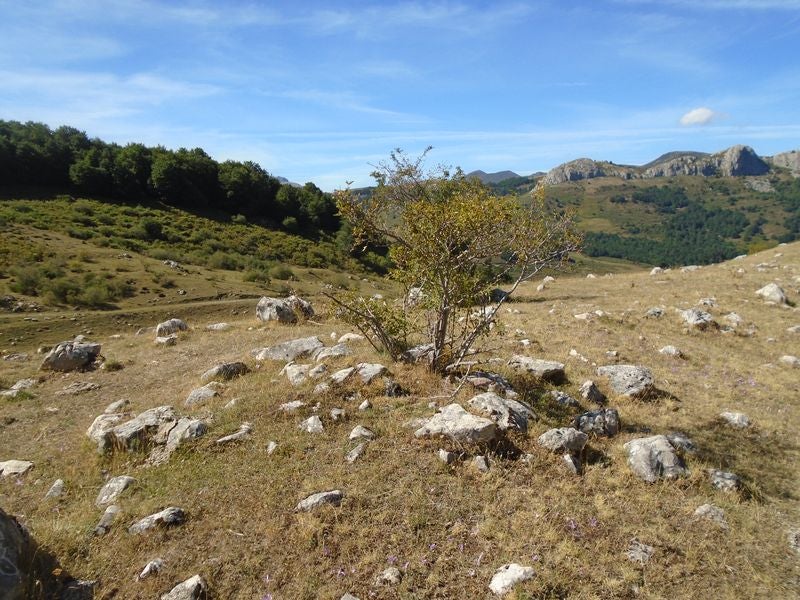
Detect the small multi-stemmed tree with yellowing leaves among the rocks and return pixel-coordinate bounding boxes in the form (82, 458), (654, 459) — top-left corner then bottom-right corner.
(331, 148), (579, 371)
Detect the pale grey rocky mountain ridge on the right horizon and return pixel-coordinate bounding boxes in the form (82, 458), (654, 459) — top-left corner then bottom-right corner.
(541, 145), (780, 186)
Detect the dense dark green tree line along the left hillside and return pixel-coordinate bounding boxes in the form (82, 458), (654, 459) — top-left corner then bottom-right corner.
(0, 120), (340, 234)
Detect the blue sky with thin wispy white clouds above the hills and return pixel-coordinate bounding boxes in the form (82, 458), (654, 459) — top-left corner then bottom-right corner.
(0, 0), (800, 190)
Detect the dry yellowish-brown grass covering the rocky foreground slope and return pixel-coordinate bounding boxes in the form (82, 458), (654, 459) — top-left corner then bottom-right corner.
(0, 244), (800, 600)
